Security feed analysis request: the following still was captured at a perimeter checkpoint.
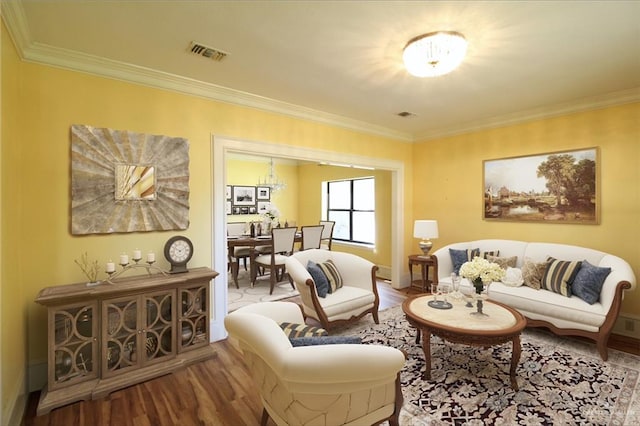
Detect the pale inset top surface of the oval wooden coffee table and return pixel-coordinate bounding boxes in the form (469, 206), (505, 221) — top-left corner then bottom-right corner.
(409, 295), (517, 331)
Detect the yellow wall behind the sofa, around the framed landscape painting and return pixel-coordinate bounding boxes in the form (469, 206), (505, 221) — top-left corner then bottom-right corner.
(413, 103), (640, 317)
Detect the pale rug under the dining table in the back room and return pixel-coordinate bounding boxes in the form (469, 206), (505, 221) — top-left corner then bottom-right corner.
(227, 270), (299, 312)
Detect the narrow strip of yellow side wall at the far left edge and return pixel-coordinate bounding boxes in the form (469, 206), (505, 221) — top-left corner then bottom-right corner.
(0, 20), (27, 424)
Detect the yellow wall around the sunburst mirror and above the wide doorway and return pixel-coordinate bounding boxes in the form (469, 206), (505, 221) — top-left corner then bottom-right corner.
(1, 19), (412, 420)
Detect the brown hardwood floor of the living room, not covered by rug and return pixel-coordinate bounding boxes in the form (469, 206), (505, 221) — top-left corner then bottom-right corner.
(23, 282), (640, 426)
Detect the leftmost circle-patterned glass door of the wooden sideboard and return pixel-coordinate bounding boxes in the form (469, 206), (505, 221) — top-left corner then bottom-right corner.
(49, 302), (98, 389)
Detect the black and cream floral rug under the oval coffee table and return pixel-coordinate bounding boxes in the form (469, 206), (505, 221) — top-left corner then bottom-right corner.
(334, 306), (640, 426)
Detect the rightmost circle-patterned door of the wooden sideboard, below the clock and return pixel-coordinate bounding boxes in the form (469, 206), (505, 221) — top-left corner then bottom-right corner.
(178, 284), (209, 352)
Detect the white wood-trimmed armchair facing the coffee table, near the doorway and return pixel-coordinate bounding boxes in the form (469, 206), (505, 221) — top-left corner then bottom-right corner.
(286, 249), (380, 330)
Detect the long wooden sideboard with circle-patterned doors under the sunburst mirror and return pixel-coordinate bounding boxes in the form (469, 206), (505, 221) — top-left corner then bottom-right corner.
(35, 268), (218, 415)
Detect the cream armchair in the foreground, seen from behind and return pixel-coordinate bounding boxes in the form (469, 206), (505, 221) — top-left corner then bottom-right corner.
(225, 302), (405, 426)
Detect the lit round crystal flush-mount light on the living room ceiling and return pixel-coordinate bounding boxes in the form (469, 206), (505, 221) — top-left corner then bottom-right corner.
(402, 31), (467, 77)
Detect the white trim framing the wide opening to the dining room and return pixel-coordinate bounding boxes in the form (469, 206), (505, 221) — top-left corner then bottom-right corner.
(211, 135), (405, 341)
